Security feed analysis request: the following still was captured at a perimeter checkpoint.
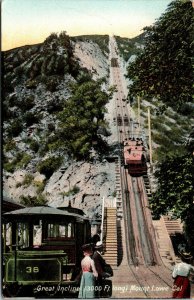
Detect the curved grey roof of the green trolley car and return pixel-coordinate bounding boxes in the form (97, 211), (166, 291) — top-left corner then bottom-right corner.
(3, 206), (86, 220)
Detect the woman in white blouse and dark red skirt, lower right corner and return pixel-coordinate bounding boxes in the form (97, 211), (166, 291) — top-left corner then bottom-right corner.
(172, 252), (194, 299)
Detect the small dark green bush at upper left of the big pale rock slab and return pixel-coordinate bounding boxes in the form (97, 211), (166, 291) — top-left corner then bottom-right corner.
(37, 156), (62, 179)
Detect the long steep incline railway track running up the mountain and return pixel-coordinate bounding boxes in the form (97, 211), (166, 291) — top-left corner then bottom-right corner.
(110, 38), (172, 298)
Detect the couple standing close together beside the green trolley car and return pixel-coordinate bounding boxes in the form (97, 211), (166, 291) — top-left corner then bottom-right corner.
(78, 237), (111, 298)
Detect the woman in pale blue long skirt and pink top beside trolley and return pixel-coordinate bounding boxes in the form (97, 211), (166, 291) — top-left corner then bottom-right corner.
(78, 244), (98, 298)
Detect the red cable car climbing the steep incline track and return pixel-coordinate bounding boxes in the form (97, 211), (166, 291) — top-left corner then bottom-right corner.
(124, 139), (147, 176)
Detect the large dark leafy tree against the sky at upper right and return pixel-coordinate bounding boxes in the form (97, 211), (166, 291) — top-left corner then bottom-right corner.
(128, 0), (194, 110)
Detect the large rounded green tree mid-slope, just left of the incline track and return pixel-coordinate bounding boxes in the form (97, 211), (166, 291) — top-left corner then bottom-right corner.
(58, 80), (113, 159)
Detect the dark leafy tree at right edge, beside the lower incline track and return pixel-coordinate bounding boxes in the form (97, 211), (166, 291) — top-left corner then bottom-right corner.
(150, 153), (194, 245)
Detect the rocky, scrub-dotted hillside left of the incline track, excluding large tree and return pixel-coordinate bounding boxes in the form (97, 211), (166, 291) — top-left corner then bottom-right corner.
(3, 33), (115, 217)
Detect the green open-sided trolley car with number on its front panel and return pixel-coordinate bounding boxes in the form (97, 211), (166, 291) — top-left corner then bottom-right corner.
(2, 206), (91, 297)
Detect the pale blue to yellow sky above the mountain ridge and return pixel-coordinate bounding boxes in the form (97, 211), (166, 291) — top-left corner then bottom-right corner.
(1, 0), (171, 50)
